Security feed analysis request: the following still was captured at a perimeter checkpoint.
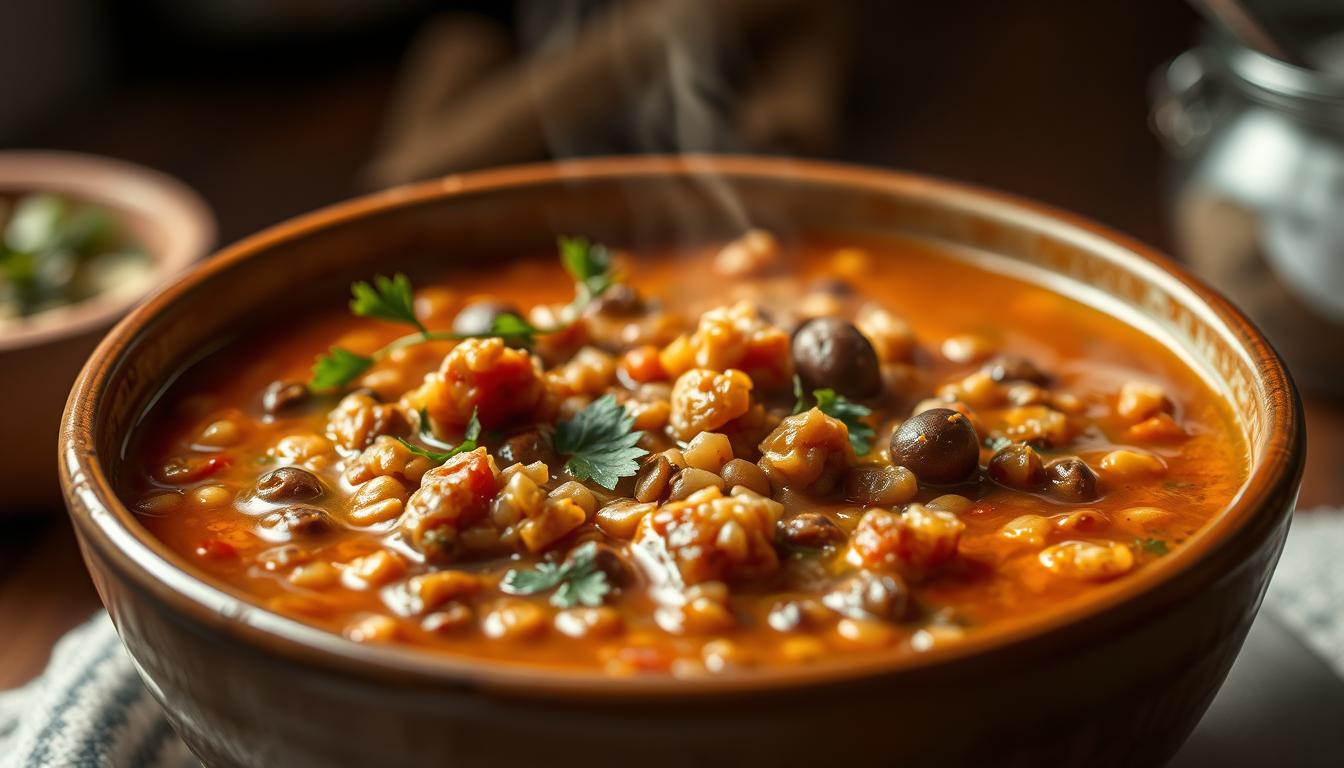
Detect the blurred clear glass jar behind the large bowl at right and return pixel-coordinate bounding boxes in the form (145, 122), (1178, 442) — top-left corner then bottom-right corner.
(1152, 27), (1344, 397)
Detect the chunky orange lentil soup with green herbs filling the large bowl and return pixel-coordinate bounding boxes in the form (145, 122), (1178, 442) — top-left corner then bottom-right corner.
(122, 231), (1247, 677)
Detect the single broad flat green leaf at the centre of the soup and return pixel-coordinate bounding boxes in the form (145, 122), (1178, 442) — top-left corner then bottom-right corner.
(552, 394), (648, 490)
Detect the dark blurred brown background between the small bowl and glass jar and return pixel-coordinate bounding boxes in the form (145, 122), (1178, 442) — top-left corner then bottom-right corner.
(0, 0), (1196, 248)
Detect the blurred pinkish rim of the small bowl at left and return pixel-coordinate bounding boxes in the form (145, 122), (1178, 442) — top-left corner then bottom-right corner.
(0, 149), (218, 352)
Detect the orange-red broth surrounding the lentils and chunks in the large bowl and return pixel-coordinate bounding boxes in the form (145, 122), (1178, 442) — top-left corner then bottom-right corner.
(122, 237), (1247, 675)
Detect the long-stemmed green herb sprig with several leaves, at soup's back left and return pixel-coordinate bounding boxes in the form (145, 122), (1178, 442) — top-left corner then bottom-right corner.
(308, 237), (616, 391)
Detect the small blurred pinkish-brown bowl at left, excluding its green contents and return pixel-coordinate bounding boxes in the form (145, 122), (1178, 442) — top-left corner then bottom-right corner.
(0, 152), (215, 516)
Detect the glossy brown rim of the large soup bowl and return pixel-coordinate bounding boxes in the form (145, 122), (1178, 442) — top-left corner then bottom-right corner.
(59, 155), (1305, 701)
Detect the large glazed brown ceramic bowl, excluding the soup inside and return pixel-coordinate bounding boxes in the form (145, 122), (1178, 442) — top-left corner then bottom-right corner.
(60, 157), (1304, 767)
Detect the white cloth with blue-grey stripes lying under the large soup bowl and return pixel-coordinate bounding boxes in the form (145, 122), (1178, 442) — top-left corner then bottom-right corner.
(0, 510), (1344, 768)
